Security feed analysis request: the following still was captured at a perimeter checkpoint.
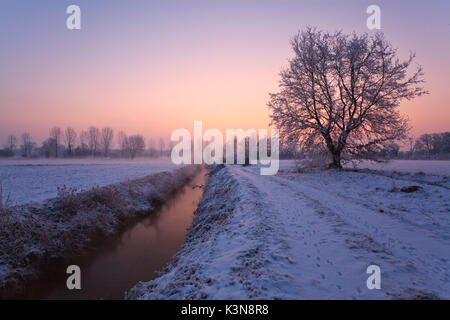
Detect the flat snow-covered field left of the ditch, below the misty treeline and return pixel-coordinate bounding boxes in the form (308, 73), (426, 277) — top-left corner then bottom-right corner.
(0, 159), (175, 204)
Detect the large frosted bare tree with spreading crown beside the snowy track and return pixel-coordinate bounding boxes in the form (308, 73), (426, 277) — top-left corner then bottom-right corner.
(268, 28), (427, 168)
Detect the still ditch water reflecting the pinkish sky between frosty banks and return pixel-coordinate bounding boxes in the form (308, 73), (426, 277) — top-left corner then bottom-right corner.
(35, 171), (207, 299)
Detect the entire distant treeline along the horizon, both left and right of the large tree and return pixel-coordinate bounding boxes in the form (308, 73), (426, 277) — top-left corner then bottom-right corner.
(0, 127), (450, 160)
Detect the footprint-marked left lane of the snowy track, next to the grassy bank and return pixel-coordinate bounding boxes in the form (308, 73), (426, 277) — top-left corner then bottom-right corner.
(232, 167), (384, 299)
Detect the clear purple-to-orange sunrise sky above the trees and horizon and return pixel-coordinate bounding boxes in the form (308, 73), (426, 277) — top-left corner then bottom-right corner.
(0, 0), (450, 145)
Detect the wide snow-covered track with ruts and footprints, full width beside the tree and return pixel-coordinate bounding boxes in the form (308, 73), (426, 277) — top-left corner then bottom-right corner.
(231, 166), (450, 298)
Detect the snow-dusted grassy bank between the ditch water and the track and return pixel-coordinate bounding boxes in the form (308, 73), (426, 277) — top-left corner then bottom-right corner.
(126, 165), (276, 300)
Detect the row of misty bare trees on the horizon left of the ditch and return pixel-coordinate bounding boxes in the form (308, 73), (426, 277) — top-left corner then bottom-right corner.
(0, 126), (171, 158)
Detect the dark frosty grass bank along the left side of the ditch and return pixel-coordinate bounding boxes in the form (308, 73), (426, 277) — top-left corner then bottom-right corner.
(0, 166), (199, 297)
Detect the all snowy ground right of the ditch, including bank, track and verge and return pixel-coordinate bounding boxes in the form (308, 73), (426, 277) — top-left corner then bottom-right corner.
(128, 162), (450, 299)
